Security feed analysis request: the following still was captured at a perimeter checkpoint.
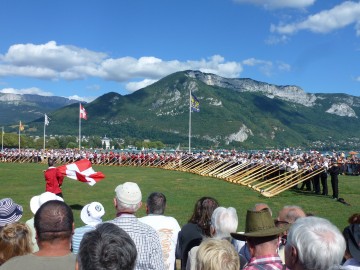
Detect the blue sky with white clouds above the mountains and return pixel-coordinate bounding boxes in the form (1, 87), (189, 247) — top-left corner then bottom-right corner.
(0, 0), (360, 101)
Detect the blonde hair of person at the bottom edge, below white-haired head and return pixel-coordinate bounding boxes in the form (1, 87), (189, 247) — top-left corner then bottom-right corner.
(196, 238), (240, 270)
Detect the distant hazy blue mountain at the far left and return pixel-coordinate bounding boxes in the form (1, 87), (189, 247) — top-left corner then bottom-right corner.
(0, 93), (79, 125)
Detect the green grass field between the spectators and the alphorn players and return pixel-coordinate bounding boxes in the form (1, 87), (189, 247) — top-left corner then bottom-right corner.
(0, 163), (360, 231)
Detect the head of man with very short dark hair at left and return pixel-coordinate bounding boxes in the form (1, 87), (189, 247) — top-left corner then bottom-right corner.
(34, 200), (74, 243)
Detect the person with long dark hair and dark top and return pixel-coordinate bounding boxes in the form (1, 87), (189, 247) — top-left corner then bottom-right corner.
(176, 197), (219, 270)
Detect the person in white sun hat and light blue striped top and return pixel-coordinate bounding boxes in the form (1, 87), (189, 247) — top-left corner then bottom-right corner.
(72, 202), (105, 254)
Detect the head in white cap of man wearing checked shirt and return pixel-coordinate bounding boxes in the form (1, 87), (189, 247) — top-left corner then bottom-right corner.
(114, 182), (142, 213)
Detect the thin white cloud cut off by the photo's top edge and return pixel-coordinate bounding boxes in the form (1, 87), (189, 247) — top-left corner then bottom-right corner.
(234, 0), (316, 9)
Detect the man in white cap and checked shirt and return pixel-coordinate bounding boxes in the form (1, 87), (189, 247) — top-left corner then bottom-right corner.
(109, 182), (165, 270)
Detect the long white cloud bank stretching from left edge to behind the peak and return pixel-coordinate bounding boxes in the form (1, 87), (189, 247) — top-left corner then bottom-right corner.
(0, 41), (242, 90)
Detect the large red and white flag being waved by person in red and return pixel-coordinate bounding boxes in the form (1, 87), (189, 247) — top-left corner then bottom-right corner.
(57, 159), (105, 186)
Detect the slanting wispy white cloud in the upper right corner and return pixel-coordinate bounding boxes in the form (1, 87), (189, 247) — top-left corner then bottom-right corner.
(270, 1), (360, 35)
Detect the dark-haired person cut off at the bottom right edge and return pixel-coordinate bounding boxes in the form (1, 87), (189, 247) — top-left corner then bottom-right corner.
(342, 224), (360, 269)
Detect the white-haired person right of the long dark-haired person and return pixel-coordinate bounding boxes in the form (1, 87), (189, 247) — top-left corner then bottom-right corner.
(186, 206), (243, 270)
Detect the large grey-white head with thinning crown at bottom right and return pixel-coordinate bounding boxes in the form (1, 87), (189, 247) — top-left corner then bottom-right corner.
(285, 217), (345, 270)
